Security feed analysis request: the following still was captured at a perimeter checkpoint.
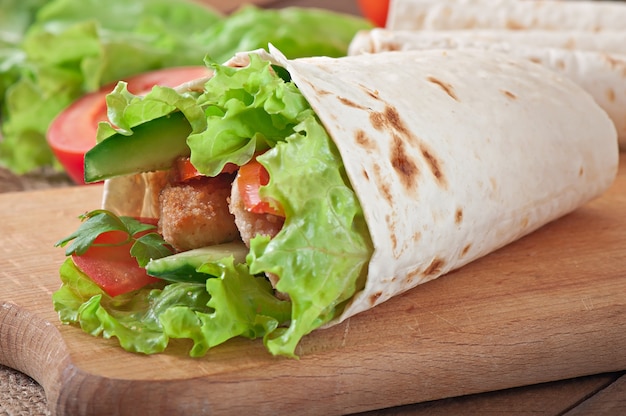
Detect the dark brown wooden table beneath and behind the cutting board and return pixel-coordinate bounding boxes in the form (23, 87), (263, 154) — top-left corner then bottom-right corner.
(0, 0), (626, 416)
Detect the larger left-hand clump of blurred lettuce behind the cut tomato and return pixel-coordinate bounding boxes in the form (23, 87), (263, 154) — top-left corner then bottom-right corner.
(0, 0), (222, 173)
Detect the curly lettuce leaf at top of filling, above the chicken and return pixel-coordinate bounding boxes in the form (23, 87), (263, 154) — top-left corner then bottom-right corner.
(187, 54), (313, 176)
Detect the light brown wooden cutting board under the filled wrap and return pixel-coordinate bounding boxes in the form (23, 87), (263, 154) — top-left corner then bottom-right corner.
(0, 158), (626, 415)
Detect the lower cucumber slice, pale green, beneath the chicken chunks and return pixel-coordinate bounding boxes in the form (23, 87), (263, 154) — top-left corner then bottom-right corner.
(146, 242), (248, 283)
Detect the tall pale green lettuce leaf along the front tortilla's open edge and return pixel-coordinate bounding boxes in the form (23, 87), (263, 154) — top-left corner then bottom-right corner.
(248, 116), (372, 356)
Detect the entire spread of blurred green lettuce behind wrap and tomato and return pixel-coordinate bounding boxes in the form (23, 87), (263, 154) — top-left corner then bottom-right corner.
(0, 0), (371, 174)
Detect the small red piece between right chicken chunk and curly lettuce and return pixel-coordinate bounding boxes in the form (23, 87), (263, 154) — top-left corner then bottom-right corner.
(237, 159), (285, 217)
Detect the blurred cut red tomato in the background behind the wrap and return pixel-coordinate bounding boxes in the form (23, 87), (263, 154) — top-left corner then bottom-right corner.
(47, 66), (209, 185)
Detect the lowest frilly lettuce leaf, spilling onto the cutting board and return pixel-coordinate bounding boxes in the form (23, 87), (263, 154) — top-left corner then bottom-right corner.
(52, 257), (291, 357)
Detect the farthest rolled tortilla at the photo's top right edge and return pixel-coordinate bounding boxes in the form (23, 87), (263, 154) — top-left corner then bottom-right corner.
(385, 0), (626, 32)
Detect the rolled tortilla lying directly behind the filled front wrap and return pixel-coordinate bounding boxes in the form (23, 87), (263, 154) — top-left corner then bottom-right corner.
(349, 29), (626, 149)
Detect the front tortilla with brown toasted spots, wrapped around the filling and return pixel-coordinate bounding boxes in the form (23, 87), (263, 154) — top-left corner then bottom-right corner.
(104, 48), (618, 325)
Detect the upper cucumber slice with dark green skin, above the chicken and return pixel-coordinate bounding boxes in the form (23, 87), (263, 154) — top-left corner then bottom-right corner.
(85, 112), (191, 183)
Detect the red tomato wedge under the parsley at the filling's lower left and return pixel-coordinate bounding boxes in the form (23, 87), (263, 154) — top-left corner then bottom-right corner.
(72, 218), (160, 296)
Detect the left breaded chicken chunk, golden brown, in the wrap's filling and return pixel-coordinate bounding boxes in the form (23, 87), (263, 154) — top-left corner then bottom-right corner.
(159, 174), (239, 251)
